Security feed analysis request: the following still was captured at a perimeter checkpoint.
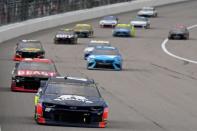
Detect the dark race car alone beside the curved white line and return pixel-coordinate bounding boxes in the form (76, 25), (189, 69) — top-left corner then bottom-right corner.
(168, 25), (189, 40)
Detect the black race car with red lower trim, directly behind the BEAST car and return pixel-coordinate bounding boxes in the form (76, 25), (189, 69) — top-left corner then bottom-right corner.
(13, 40), (45, 61)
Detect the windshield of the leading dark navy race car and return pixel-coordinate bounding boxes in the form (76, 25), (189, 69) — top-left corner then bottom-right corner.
(45, 82), (100, 97)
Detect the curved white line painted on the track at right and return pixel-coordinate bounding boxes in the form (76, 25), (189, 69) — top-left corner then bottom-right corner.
(161, 25), (197, 64)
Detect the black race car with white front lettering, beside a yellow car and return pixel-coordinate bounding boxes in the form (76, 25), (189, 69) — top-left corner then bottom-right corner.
(54, 29), (78, 44)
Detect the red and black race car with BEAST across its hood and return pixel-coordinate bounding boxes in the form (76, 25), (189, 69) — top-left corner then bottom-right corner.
(11, 58), (59, 92)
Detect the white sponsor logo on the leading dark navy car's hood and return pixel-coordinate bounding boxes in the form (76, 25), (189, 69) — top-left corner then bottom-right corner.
(54, 95), (93, 104)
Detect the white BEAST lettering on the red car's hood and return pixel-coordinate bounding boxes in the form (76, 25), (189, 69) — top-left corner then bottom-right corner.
(18, 70), (56, 77)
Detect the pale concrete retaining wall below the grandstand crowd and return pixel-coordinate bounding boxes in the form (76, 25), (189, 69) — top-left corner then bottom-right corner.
(0, 0), (186, 43)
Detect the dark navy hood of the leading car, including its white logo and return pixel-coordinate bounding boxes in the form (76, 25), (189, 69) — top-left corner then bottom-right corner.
(42, 95), (105, 106)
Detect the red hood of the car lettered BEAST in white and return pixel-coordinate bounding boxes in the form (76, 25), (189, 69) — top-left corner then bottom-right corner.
(16, 70), (57, 77)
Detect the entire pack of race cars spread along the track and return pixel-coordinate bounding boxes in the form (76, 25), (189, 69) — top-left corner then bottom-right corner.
(11, 7), (189, 128)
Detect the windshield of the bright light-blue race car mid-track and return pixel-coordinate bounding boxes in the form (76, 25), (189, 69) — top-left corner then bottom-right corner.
(92, 49), (118, 55)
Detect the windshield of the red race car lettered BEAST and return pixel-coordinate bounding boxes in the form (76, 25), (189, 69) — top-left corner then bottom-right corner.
(18, 61), (55, 72)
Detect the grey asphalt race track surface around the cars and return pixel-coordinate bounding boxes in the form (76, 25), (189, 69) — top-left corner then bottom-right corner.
(0, 0), (197, 131)
